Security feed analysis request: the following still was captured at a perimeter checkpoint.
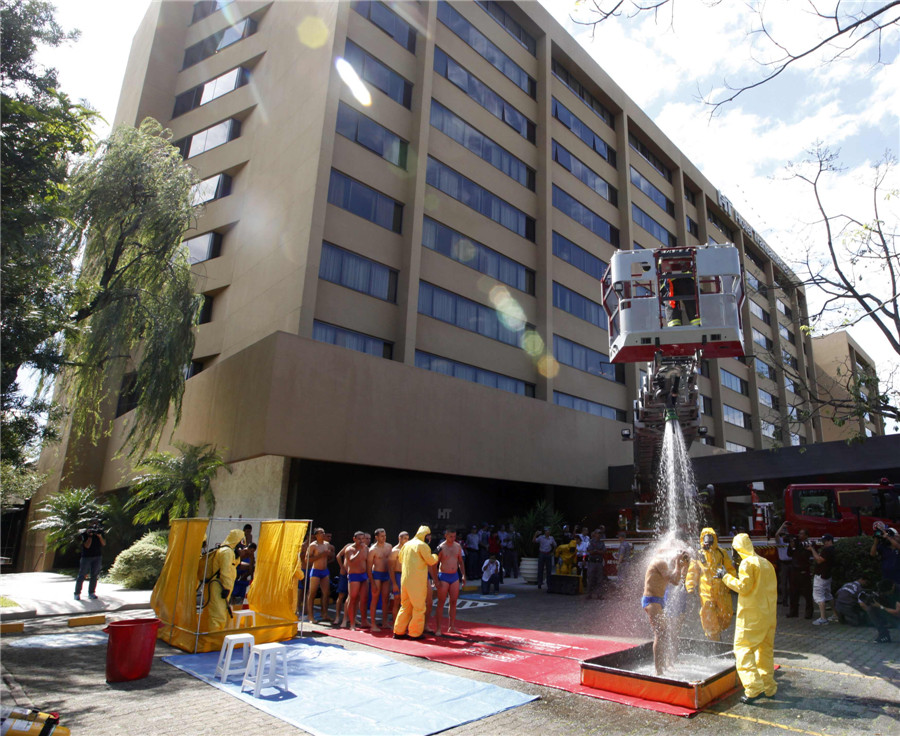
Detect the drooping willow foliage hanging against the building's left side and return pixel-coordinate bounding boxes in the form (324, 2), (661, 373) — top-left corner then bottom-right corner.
(63, 118), (201, 454)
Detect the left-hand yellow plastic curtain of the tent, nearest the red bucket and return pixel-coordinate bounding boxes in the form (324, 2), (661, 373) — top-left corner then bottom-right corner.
(150, 519), (209, 651)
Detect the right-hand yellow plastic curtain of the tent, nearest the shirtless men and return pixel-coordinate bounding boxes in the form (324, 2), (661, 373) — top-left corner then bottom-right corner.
(247, 520), (309, 622)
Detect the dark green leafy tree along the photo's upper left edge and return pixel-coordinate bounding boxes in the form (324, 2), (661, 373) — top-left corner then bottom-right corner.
(0, 0), (94, 464)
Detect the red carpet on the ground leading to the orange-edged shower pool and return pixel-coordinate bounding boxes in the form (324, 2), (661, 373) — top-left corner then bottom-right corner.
(326, 621), (732, 717)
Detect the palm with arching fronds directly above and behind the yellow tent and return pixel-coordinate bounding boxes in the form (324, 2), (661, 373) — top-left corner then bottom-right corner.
(126, 442), (231, 524)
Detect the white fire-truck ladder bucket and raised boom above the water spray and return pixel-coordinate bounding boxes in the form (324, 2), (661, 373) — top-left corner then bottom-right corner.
(602, 244), (744, 516)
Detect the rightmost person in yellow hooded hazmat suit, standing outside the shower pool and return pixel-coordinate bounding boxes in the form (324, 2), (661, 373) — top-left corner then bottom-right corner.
(716, 534), (778, 703)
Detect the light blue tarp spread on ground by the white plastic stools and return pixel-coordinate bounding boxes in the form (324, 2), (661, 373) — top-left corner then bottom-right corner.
(163, 639), (537, 736)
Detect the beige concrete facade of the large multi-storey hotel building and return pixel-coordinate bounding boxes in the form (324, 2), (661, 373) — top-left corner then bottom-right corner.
(24, 1), (821, 561)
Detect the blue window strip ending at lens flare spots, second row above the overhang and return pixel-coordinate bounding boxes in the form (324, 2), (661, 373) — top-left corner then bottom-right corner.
(419, 281), (530, 347)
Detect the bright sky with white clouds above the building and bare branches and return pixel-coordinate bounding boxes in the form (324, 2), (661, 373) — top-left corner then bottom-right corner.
(39, 0), (900, 420)
